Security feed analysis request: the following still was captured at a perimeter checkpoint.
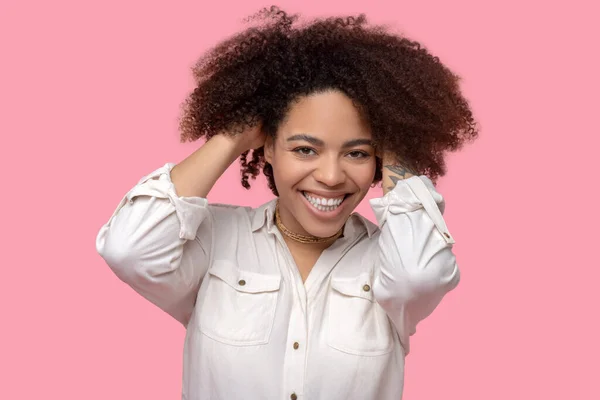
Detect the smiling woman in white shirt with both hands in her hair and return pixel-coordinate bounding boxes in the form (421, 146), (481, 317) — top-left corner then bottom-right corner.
(97, 8), (477, 400)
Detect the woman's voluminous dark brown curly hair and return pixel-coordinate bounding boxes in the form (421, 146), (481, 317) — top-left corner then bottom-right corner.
(180, 6), (478, 195)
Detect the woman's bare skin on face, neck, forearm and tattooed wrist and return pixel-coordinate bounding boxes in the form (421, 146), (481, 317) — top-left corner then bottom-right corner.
(171, 90), (414, 281)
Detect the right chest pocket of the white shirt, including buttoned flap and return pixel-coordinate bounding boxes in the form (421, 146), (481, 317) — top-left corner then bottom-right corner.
(328, 273), (394, 356)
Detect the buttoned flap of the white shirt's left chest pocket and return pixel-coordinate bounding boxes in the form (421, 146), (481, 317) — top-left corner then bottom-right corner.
(208, 260), (281, 293)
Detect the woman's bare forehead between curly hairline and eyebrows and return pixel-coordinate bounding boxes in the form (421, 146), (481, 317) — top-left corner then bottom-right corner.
(279, 91), (371, 144)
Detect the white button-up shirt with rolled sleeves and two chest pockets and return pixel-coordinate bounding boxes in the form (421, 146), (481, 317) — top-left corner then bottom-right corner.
(96, 164), (459, 400)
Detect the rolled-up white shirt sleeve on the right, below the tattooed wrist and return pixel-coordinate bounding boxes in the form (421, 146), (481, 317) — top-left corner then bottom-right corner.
(370, 175), (460, 354)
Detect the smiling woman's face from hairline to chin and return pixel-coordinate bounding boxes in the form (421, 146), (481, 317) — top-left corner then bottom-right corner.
(265, 91), (376, 237)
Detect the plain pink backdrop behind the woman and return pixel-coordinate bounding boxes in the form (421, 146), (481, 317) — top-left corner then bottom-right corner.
(0, 0), (600, 400)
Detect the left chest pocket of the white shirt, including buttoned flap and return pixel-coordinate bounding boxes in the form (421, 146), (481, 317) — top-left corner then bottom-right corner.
(199, 260), (281, 346)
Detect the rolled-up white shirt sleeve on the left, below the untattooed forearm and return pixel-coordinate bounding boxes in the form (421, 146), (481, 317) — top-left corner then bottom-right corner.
(96, 164), (212, 326)
